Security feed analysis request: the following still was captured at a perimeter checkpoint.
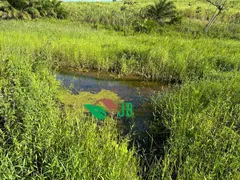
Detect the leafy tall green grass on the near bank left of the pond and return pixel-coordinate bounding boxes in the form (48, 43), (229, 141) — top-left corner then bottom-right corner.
(0, 49), (138, 180)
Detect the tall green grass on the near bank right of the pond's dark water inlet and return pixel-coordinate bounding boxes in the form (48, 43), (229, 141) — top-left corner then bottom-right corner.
(151, 77), (240, 179)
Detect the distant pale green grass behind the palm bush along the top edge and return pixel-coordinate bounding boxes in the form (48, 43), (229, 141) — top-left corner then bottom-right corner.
(63, 0), (240, 34)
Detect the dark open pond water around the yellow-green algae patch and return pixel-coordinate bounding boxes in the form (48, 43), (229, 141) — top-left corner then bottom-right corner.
(57, 69), (169, 148)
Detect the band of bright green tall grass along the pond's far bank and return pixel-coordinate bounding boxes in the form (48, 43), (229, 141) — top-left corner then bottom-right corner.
(0, 21), (239, 81)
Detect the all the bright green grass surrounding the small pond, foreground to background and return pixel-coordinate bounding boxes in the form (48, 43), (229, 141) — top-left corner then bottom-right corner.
(0, 1), (240, 179)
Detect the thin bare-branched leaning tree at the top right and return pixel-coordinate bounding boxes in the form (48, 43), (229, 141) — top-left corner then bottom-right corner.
(205, 0), (227, 32)
